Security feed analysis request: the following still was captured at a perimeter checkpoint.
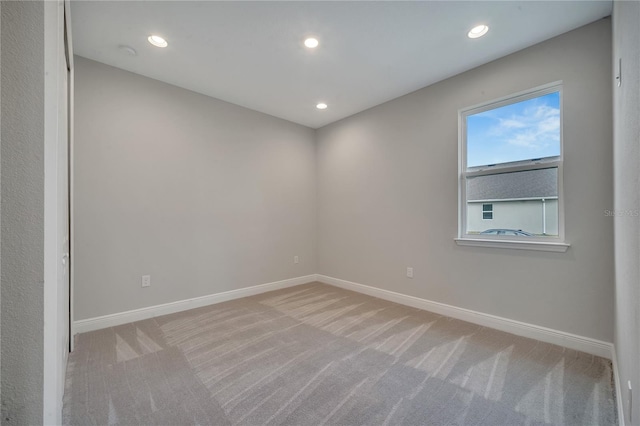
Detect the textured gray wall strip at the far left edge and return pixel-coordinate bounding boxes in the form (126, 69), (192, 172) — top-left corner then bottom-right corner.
(0, 2), (44, 425)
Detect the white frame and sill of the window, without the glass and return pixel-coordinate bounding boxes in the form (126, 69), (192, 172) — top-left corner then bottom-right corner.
(455, 81), (570, 252)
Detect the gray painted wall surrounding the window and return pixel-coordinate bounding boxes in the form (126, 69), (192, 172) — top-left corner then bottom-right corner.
(317, 19), (614, 342)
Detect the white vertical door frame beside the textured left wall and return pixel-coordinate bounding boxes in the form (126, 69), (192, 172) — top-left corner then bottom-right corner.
(42, 0), (73, 425)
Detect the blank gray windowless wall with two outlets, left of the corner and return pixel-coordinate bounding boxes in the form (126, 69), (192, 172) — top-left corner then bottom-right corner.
(73, 57), (316, 320)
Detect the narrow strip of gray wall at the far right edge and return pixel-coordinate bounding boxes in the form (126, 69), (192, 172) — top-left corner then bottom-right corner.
(611, 1), (640, 424)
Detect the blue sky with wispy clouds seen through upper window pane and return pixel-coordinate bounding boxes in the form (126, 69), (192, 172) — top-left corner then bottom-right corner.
(467, 92), (560, 167)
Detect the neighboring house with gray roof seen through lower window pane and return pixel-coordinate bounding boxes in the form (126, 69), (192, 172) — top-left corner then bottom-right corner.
(467, 168), (558, 235)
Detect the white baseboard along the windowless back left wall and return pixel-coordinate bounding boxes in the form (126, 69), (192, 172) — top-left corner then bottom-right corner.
(74, 274), (317, 333)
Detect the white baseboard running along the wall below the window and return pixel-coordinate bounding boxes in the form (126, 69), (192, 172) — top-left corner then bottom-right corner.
(318, 275), (613, 359)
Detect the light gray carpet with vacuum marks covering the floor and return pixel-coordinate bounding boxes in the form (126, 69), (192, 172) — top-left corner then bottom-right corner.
(63, 283), (616, 426)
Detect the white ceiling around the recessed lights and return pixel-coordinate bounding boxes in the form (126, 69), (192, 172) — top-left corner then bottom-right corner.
(71, 0), (612, 128)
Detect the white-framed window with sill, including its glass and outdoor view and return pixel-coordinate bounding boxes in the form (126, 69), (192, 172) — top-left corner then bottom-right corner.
(456, 83), (568, 251)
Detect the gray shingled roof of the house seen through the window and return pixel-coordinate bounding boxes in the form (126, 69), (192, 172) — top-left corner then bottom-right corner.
(467, 168), (558, 201)
